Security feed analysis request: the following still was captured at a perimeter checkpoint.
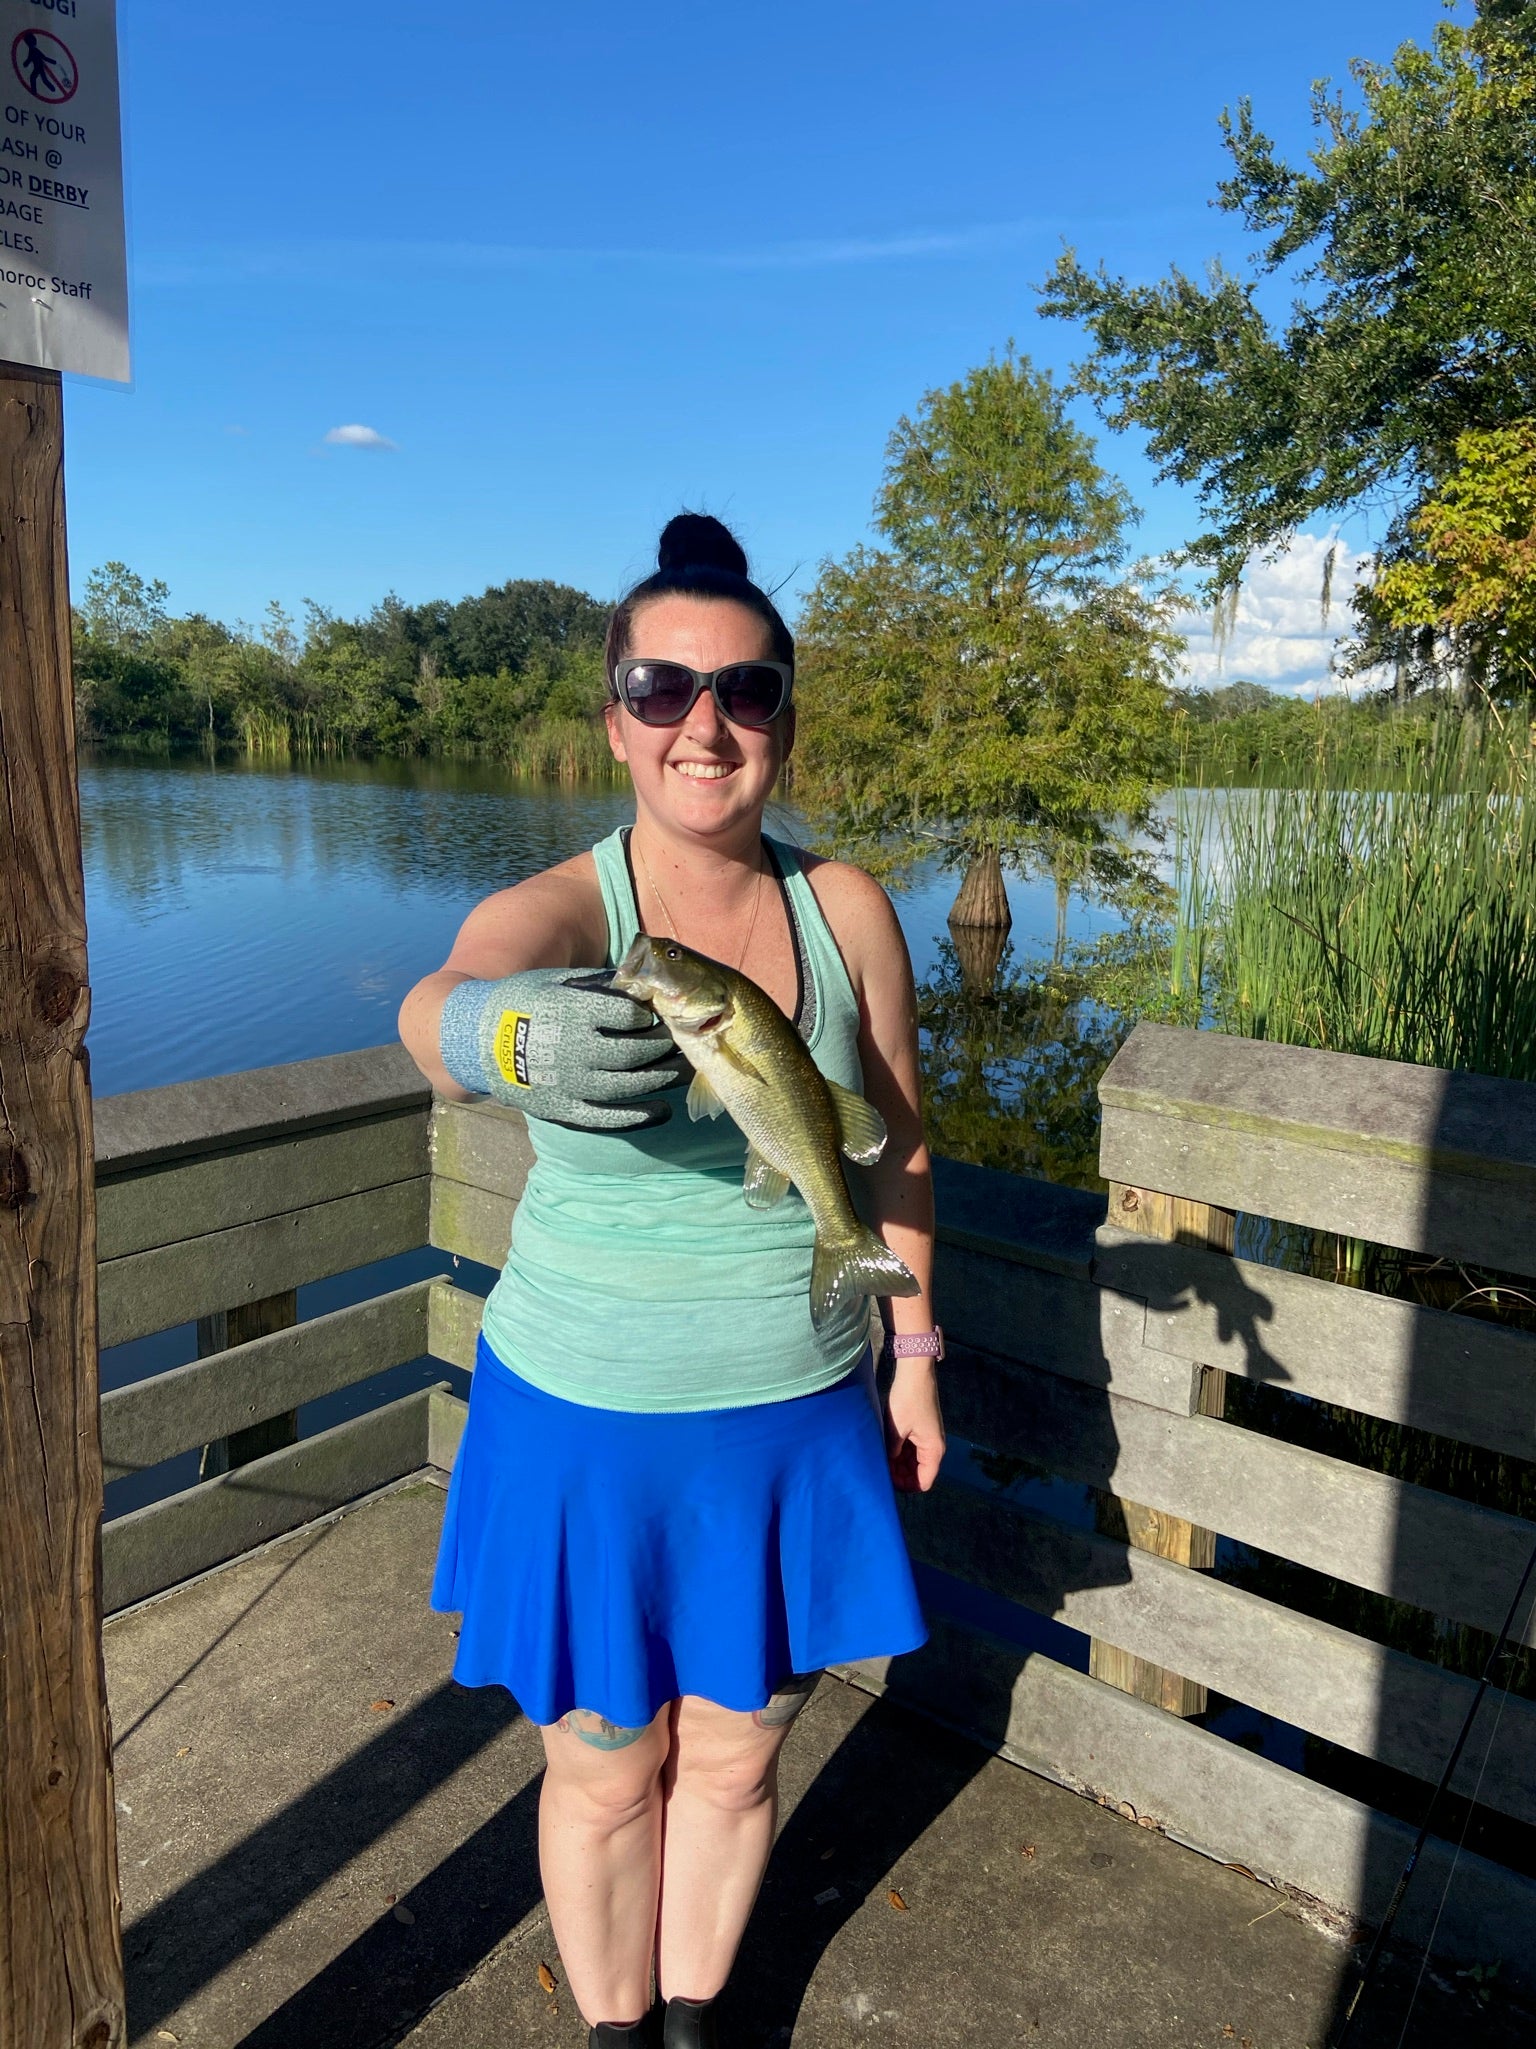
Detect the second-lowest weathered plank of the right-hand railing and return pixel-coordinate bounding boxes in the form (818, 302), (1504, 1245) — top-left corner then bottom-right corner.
(901, 1483), (1536, 1820)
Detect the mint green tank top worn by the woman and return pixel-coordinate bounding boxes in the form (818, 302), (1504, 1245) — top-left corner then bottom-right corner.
(483, 830), (868, 1410)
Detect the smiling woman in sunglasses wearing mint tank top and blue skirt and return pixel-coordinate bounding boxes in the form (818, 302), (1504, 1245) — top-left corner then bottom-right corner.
(399, 514), (944, 2049)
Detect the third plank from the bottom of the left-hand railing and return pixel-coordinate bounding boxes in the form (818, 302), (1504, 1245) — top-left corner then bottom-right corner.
(98, 1176), (428, 1344)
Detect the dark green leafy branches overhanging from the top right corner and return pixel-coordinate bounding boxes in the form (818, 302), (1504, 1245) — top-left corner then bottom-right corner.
(1042, 0), (1536, 688)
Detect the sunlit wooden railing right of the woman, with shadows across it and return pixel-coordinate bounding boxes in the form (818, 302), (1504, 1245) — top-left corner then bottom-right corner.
(860, 1025), (1536, 1975)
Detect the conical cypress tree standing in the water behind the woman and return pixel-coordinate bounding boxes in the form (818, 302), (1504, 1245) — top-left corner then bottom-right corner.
(795, 348), (1182, 926)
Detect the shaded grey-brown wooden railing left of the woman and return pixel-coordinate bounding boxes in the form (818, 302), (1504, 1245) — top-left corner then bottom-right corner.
(96, 1047), (473, 1613)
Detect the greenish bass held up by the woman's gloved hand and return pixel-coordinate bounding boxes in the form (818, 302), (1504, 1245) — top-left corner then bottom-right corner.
(610, 932), (920, 1330)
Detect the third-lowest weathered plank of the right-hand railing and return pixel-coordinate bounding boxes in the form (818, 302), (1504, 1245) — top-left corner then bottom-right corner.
(944, 1352), (1536, 1643)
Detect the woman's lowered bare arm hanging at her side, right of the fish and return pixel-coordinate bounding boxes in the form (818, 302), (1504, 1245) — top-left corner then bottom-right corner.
(807, 861), (944, 1490)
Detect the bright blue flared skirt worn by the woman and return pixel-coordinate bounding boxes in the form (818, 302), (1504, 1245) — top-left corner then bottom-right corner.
(432, 1338), (928, 1729)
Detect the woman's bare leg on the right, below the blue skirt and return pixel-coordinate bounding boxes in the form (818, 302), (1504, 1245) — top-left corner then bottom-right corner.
(655, 1674), (817, 2000)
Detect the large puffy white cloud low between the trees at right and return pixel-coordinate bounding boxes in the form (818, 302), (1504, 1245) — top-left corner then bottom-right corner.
(1178, 533), (1386, 697)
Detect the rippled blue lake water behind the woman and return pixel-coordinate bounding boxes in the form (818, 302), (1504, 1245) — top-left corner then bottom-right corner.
(80, 758), (1110, 1096)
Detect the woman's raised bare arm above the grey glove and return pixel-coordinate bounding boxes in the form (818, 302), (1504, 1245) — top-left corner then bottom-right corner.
(399, 854), (608, 1102)
